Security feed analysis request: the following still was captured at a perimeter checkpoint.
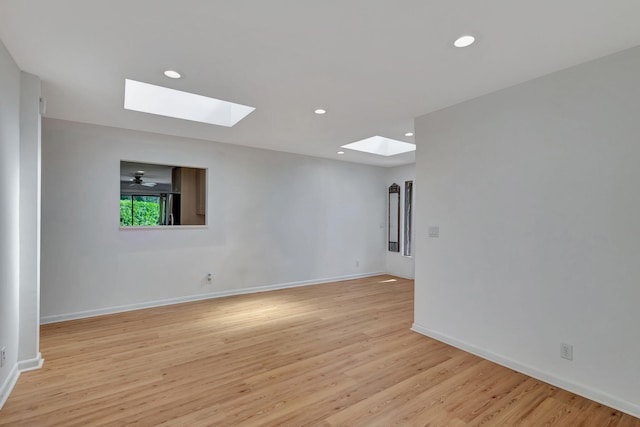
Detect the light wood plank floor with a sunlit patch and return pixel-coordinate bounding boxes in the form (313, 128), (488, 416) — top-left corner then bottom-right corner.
(0, 276), (640, 427)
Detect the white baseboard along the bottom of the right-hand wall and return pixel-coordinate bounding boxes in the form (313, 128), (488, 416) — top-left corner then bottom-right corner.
(411, 323), (640, 418)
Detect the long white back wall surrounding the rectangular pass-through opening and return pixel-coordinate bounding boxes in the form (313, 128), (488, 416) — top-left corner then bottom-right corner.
(41, 120), (386, 322)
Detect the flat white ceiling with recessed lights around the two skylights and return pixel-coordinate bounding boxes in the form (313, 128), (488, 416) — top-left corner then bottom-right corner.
(0, 0), (640, 166)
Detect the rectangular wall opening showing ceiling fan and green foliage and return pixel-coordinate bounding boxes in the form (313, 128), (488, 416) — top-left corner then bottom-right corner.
(120, 161), (207, 227)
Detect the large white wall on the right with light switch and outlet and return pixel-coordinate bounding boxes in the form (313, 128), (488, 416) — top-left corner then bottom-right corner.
(414, 48), (640, 416)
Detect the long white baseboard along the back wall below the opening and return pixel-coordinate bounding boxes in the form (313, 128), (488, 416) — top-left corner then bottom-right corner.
(45, 272), (386, 325)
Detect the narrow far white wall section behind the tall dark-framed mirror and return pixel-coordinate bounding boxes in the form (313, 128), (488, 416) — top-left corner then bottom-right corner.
(386, 164), (416, 279)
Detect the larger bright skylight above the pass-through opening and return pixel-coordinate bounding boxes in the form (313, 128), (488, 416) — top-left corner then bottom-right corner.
(124, 79), (255, 127)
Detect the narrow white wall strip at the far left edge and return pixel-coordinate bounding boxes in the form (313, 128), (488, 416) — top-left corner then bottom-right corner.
(0, 42), (20, 407)
